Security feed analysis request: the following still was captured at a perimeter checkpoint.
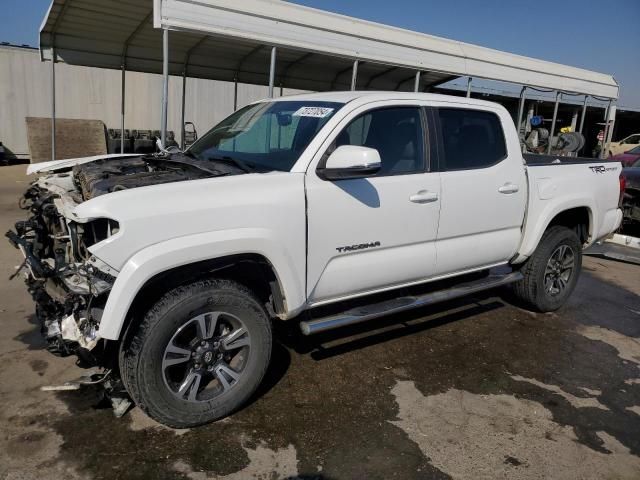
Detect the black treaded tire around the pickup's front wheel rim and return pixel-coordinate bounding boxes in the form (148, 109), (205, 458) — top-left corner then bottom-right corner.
(119, 280), (272, 428)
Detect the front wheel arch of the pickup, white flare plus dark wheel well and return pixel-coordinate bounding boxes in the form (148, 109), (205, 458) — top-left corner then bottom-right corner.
(98, 232), (304, 340)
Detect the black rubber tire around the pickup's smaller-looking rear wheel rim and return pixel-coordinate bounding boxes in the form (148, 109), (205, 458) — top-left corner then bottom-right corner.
(512, 225), (582, 312)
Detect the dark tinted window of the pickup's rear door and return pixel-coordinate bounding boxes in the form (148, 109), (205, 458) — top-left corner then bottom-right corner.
(438, 108), (507, 170)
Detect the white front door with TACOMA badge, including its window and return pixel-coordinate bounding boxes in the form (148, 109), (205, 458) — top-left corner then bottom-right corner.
(306, 105), (440, 304)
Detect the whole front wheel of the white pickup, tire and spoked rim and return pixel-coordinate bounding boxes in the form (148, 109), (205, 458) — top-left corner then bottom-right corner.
(120, 280), (272, 428)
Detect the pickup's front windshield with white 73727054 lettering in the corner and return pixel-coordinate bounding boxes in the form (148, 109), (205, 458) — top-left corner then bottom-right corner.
(187, 101), (343, 171)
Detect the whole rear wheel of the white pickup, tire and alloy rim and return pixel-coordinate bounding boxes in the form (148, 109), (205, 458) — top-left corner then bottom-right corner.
(513, 225), (582, 312)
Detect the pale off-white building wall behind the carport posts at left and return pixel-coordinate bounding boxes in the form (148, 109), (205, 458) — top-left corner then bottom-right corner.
(0, 46), (298, 158)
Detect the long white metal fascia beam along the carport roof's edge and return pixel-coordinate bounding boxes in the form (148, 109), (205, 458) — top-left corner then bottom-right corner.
(160, 0), (618, 98)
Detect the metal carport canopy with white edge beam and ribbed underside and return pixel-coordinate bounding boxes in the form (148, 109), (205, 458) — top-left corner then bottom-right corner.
(40, 0), (619, 100)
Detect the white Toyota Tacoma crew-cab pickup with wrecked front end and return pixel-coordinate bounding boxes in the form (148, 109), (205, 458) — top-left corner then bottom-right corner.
(7, 92), (622, 427)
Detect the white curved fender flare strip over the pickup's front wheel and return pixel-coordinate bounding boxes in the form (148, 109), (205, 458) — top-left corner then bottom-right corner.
(98, 228), (305, 340)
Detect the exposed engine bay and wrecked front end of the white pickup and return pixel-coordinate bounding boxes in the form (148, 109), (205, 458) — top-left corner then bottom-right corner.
(6, 153), (232, 366)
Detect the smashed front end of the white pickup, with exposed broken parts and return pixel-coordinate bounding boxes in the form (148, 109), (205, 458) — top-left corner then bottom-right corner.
(6, 174), (119, 368)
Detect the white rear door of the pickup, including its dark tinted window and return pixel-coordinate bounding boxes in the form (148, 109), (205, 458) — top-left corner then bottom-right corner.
(432, 104), (527, 275)
